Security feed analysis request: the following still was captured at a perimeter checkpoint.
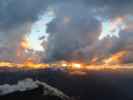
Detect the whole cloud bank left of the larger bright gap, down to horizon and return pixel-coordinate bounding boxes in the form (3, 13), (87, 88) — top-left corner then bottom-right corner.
(0, 0), (49, 61)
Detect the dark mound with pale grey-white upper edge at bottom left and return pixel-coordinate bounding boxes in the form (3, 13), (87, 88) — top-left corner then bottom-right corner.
(0, 79), (70, 100)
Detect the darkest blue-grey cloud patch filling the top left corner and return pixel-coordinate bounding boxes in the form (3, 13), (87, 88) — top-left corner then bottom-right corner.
(0, 0), (48, 30)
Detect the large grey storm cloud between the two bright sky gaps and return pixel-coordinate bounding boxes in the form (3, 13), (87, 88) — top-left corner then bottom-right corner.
(44, 0), (133, 60)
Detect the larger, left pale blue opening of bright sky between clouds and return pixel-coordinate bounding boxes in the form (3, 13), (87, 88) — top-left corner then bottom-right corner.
(27, 11), (54, 51)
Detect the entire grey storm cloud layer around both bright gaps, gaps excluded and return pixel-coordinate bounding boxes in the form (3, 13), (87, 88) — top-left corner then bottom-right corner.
(0, 0), (133, 60)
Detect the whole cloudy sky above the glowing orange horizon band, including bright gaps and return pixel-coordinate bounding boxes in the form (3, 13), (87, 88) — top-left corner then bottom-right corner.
(0, 0), (133, 63)
